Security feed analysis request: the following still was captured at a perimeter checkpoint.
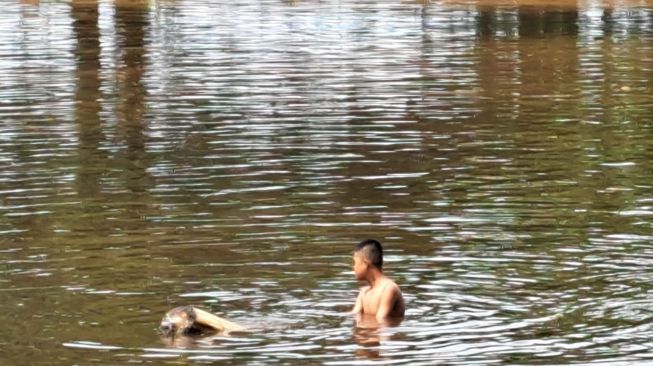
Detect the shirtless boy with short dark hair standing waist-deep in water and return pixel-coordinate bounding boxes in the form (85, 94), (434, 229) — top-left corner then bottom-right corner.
(352, 239), (406, 322)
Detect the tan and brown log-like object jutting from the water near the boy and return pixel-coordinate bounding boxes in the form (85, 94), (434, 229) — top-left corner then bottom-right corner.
(159, 305), (245, 337)
